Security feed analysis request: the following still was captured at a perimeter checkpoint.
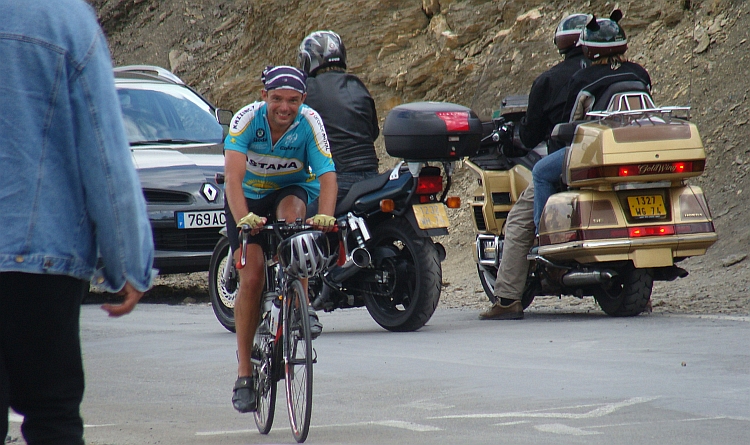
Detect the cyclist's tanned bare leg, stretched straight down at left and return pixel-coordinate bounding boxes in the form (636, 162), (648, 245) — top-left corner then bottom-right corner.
(234, 244), (265, 377)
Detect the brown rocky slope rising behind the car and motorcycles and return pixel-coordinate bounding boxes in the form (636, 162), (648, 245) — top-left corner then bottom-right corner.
(95, 0), (750, 314)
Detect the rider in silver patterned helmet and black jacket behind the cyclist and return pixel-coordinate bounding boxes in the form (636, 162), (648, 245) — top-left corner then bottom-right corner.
(298, 31), (380, 205)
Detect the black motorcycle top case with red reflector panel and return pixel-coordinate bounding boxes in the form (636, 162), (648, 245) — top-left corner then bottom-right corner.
(383, 102), (482, 161)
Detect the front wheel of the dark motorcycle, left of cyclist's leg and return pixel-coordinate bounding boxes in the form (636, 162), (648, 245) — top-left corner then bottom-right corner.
(208, 236), (240, 332)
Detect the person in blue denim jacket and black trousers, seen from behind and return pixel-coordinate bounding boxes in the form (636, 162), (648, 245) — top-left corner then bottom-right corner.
(0, 0), (153, 445)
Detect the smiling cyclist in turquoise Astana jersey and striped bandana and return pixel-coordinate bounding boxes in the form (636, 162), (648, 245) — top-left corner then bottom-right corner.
(224, 66), (337, 412)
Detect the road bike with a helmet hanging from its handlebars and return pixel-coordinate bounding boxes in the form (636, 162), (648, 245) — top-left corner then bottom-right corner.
(236, 220), (330, 443)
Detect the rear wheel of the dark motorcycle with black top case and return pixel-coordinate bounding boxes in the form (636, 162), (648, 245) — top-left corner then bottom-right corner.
(364, 218), (442, 332)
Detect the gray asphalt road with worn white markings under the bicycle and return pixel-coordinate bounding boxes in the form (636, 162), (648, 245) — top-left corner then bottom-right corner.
(11, 305), (750, 445)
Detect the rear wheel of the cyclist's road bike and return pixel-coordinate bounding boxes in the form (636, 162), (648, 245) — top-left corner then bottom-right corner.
(252, 322), (281, 434)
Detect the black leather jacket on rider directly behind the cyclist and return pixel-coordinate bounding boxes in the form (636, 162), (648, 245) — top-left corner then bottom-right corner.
(305, 70), (380, 173)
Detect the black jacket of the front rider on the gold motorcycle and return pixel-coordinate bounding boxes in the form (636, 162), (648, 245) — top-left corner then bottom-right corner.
(519, 47), (589, 153)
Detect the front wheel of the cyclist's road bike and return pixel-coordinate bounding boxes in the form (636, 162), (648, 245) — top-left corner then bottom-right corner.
(284, 280), (313, 443)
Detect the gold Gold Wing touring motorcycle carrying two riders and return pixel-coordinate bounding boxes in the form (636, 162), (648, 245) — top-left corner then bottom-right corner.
(466, 89), (717, 316)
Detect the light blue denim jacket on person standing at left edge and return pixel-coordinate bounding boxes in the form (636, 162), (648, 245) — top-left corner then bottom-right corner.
(0, 0), (153, 291)
